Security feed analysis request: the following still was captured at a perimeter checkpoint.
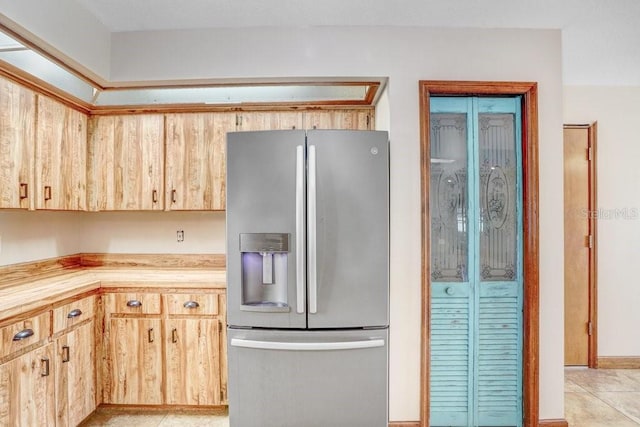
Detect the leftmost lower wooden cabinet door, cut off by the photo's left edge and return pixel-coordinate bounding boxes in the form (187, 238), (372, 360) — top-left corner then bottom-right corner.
(0, 344), (55, 427)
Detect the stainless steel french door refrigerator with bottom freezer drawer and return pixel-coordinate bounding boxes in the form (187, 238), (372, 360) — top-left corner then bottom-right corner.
(227, 130), (389, 427)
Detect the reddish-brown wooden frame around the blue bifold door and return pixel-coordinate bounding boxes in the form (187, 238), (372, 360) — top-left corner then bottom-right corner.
(419, 80), (540, 427)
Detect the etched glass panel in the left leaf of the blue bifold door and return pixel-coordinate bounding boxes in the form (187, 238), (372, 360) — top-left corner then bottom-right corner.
(429, 113), (468, 282)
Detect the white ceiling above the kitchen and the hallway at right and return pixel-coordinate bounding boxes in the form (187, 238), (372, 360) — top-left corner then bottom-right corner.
(70, 0), (640, 85)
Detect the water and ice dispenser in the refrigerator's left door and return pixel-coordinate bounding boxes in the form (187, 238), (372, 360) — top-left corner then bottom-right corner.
(240, 233), (290, 312)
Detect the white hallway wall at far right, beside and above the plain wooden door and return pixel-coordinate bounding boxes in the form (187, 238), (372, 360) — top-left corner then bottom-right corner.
(564, 86), (640, 357)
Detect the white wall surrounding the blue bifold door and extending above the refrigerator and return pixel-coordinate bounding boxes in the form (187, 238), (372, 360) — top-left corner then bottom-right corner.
(106, 27), (563, 420)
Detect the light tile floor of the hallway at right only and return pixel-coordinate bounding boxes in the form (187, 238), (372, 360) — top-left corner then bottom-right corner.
(564, 368), (640, 427)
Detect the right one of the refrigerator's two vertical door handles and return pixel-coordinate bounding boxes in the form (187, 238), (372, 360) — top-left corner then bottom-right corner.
(307, 145), (318, 314)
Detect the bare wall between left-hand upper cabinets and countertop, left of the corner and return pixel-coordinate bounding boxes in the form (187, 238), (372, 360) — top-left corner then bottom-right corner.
(0, 211), (82, 266)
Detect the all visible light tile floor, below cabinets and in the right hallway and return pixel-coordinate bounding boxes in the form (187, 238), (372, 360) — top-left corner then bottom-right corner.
(81, 368), (640, 427)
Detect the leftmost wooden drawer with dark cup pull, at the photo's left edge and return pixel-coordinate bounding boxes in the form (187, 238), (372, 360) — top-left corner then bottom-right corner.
(0, 311), (51, 357)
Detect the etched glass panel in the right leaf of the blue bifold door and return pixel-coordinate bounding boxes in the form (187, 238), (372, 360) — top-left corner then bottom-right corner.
(478, 113), (517, 281)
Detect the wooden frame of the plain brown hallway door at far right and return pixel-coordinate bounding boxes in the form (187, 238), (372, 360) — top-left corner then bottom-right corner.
(563, 122), (598, 368)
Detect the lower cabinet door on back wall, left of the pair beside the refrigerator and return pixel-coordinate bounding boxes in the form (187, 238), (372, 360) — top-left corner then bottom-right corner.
(104, 318), (163, 405)
